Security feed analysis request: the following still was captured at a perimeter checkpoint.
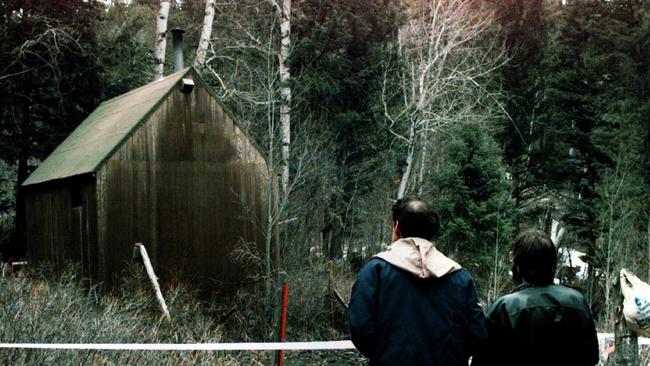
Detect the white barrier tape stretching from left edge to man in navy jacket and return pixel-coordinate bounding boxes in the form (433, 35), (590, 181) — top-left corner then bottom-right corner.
(0, 341), (355, 351)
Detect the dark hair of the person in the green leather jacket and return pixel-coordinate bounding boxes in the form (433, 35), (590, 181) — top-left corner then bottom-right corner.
(512, 229), (557, 286)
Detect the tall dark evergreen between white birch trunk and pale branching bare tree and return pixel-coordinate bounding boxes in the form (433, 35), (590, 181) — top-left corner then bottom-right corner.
(292, 0), (402, 257)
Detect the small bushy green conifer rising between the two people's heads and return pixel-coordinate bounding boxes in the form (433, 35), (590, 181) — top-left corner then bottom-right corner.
(432, 123), (517, 302)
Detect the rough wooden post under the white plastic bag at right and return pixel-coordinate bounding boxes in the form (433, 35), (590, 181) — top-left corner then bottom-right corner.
(607, 276), (639, 366)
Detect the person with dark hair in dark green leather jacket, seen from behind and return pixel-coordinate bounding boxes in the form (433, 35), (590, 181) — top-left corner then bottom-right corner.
(472, 230), (599, 366)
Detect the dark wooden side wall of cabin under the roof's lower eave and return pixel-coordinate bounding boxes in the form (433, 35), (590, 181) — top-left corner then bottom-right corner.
(25, 176), (97, 275)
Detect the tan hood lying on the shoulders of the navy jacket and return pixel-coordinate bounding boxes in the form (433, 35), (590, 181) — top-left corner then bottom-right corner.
(375, 238), (462, 278)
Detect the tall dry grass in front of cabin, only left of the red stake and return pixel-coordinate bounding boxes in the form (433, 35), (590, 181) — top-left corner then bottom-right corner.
(0, 266), (270, 365)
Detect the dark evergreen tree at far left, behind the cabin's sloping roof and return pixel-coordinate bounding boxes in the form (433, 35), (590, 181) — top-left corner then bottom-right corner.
(0, 0), (101, 256)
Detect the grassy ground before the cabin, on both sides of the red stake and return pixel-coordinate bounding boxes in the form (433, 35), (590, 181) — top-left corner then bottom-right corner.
(0, 266), (362, 365)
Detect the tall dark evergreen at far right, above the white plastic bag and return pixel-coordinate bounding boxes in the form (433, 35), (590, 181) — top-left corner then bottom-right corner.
(492, 0), (648, 316)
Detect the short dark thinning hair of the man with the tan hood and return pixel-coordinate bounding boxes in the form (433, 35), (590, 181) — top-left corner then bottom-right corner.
(393, 196), (440, 240)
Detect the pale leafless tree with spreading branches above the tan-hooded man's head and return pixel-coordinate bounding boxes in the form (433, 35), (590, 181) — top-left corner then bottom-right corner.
(382, 0), (506, 198)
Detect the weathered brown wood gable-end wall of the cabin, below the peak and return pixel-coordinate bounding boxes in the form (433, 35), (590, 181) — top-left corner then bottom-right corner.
(97, 78), (267, 286)
